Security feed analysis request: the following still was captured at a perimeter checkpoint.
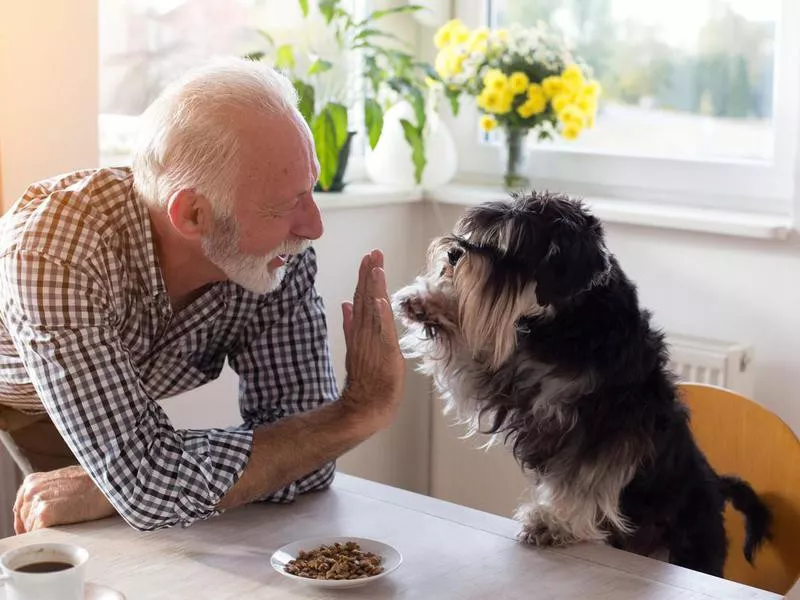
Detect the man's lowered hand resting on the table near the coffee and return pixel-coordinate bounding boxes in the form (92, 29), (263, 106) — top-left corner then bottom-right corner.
(14, 466), (116, 534)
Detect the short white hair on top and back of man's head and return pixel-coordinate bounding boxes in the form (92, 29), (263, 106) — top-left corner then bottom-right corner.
(133, 58), (297, 218)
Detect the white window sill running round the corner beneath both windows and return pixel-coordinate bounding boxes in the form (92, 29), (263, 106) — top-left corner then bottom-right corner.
(315, 182), (794, 240)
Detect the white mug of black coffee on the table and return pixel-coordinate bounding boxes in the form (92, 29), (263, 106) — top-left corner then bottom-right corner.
(0, 543), (89, 600)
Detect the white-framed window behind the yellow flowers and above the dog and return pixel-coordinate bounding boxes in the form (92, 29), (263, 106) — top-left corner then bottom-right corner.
(450, 0), (800, 212)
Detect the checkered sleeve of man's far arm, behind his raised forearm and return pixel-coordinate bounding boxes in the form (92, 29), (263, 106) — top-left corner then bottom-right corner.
(228, 249), (338, 502)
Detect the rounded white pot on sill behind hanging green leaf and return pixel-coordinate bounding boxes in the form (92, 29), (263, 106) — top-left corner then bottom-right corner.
(366, 102), (458, 188)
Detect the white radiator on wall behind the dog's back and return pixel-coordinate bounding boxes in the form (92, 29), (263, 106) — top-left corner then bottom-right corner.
(667, 334), (755, 398)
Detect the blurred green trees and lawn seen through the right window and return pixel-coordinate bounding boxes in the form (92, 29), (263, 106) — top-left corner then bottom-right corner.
(498, 0), (775, 118)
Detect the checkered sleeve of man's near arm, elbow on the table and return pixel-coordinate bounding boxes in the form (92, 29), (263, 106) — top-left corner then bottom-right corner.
(0, 247), (252, 530)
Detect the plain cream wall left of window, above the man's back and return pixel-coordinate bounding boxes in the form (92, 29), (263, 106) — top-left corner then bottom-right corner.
(0, 0), (98, 208)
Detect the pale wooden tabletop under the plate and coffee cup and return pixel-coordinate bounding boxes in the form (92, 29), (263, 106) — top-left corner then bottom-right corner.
(0, 473), (780, 600)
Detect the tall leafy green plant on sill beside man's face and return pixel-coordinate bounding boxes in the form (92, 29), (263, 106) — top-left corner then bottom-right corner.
(247, 0), (434, 192)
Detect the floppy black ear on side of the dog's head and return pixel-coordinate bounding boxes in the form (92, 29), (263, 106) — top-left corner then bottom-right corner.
(536, 210), (610, 306)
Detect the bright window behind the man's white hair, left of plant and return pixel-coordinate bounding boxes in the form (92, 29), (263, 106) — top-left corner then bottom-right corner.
(99, 0), (361, 165)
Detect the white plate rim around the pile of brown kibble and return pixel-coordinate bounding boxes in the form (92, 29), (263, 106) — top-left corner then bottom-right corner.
(270, 537), (403, 588)
